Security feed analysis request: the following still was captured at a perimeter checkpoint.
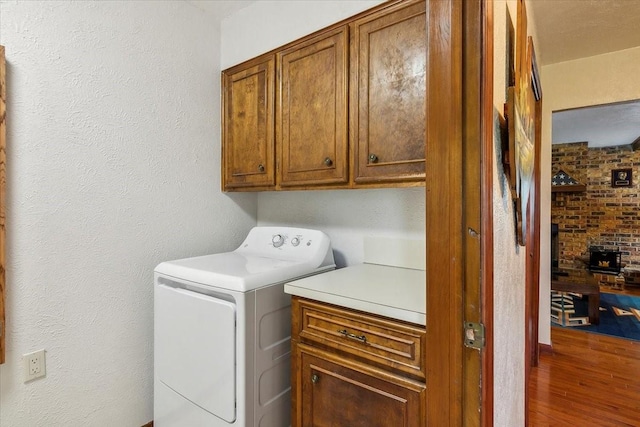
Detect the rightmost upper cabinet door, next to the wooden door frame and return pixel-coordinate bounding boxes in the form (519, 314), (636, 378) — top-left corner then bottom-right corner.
(351, 0), (427, 183)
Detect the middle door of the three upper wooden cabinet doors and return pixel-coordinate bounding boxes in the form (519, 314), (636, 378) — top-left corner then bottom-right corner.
(276, 26), (348, 187)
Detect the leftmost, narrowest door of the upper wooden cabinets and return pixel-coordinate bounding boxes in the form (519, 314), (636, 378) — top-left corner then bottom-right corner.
(222, 55), (275, 190)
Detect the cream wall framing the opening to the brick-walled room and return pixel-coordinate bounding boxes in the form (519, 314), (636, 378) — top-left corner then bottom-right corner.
(539, 47), (640, 344)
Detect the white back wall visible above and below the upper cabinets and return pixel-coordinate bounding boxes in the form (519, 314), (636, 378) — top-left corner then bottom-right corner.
(221, 1), (425, 267)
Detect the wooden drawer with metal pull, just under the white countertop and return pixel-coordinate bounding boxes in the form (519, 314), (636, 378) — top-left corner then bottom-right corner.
(292, 297), (425, 380)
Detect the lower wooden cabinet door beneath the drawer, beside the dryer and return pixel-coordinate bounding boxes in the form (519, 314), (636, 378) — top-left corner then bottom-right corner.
(297, 344), (425, 427)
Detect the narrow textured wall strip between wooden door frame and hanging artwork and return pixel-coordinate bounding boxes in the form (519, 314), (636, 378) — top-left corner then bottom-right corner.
(493, 0), (526, 426)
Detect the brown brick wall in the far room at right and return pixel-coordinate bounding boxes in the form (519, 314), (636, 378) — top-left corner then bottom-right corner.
(551, 142), (640, 280)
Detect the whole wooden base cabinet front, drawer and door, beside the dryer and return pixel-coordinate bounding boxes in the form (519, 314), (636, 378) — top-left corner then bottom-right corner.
(291, 296), (426, 427)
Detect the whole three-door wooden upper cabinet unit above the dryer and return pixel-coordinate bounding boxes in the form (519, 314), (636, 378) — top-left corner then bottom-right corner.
(222, 0), (427, 191)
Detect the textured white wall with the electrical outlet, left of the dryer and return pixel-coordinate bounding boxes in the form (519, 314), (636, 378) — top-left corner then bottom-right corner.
(0, 1), (257, 427)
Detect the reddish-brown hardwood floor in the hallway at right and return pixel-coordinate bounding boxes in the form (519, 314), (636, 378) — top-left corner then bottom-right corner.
(529, 327), (640, 427)
